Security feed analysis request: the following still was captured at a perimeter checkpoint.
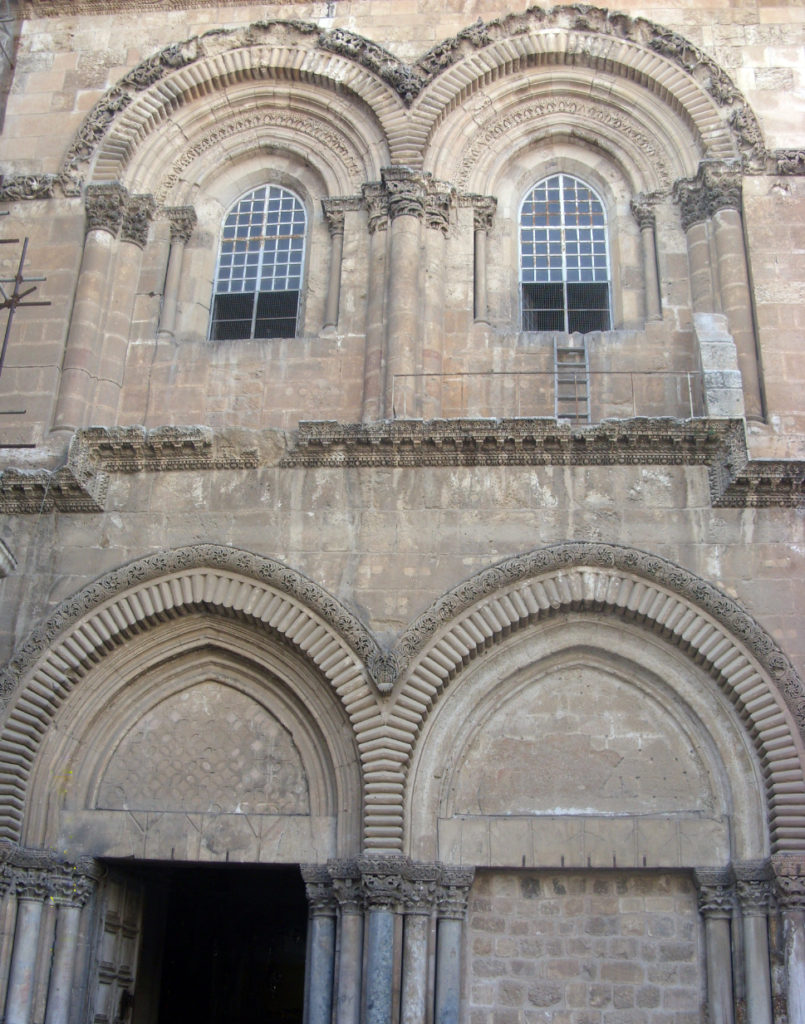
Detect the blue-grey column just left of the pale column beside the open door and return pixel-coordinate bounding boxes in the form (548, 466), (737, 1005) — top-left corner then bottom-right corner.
(5, 866), (49, 1024)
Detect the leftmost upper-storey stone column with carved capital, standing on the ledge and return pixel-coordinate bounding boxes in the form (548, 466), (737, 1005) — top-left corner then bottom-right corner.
(53, 184), (127, 430)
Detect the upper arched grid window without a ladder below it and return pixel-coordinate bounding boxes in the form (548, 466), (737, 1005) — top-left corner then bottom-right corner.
(210, 185), (306, 341)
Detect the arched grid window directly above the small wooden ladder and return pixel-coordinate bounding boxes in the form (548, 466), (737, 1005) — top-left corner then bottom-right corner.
(520, 174), (611, 334)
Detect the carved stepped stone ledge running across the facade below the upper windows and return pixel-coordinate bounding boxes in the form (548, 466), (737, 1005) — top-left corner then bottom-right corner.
(0, 417), (805, 515)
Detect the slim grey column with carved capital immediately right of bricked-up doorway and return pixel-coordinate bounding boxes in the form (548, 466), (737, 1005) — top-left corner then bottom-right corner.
(694, 868), (734, 1024)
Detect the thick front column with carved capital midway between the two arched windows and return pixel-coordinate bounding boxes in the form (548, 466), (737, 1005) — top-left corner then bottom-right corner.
(383, 167), (428, 418)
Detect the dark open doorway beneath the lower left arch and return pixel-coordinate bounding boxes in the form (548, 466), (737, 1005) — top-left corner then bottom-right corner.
(132, 865), (307, 1024)
